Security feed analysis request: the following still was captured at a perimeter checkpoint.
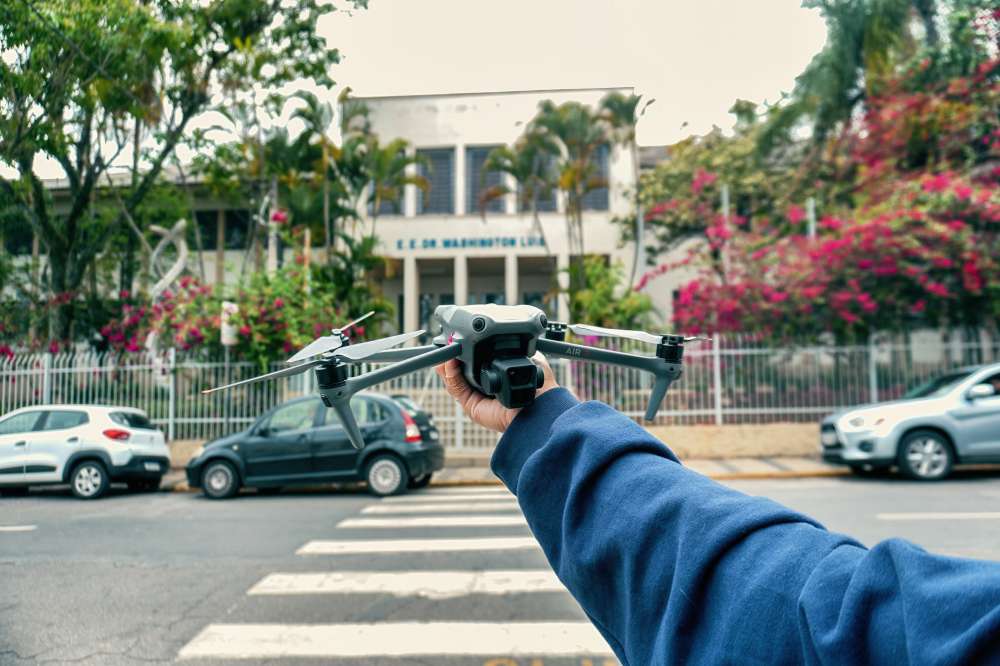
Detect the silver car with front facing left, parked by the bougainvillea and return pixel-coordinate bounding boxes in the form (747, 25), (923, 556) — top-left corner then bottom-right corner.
(820, 363), (1000, 481)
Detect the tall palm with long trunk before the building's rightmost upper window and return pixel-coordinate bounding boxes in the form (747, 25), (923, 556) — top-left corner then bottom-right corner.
(527, 100), (611, 294)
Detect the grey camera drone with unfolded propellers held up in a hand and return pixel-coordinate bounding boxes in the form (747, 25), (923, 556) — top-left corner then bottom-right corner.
(203, 304), (706, 449)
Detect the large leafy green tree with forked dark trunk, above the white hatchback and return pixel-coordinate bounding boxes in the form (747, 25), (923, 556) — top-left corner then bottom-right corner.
(0, 0), (364, 340)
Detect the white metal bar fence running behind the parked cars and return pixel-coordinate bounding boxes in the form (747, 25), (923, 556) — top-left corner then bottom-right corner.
(0, 334), (1000, 449)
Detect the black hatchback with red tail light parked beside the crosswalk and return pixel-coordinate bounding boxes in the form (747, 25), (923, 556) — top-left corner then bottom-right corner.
(187, 393), (444, 499)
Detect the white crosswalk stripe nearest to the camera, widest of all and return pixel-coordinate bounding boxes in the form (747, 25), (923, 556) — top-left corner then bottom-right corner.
(178, 622), (611, 659)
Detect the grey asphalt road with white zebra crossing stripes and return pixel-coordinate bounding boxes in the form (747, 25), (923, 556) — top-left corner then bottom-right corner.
(0, 473), (1000, 666)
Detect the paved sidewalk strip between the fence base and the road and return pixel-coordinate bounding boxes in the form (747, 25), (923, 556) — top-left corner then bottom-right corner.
(162, 453), (850, 492)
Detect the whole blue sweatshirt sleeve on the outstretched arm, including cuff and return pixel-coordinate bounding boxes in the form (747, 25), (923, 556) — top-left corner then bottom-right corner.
(492, 389), (1000, 666)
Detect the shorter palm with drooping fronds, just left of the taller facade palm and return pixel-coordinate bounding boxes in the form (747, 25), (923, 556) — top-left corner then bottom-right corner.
(479, 133), (558, 252)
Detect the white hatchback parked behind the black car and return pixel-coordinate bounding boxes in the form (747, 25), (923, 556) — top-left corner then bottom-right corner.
(0, 405), (170, 499)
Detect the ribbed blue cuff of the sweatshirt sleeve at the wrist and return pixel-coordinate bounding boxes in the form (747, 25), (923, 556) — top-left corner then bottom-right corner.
(490, 387), (580, 493)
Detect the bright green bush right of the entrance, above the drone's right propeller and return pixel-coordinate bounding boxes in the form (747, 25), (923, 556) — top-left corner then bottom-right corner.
(569, 255), (653, 328)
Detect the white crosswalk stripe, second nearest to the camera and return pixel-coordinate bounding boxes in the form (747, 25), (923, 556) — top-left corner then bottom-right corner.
(247, 569), (566, 599)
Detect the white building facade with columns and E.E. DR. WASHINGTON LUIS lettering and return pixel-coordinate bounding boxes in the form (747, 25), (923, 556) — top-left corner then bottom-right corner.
(354, 88), (666, 330)
